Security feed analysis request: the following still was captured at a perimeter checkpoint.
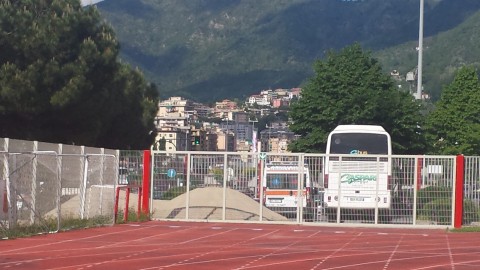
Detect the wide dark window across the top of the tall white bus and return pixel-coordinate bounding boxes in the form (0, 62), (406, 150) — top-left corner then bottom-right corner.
(330, 133), (389, 155)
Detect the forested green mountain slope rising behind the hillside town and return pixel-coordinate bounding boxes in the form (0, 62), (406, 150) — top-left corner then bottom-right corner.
(98, 0), (480, 102)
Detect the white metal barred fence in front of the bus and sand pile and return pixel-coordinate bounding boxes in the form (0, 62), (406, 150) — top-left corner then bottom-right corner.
(151, 152), (480, 226)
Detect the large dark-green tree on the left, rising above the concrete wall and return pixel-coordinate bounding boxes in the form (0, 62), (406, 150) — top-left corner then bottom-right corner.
(0, 0), (158, 149)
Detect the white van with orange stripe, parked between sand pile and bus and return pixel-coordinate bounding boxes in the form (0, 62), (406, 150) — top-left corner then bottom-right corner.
(263, 162), (312, 218)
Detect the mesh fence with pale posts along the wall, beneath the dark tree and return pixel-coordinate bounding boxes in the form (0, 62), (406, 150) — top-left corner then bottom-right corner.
(0, 139), (118, 235)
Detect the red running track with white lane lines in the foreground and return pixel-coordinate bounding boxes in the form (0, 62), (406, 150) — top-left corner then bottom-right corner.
(0, 221), (480, 270)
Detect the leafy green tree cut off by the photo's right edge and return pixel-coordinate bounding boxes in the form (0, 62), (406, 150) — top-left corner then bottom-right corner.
(426, 66), (480, 155)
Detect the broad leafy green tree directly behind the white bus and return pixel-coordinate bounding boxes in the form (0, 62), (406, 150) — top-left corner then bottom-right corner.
(290, 44), (424, 154)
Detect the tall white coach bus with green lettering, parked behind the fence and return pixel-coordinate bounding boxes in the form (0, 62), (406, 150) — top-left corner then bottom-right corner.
(324, 125), (392, 219)
